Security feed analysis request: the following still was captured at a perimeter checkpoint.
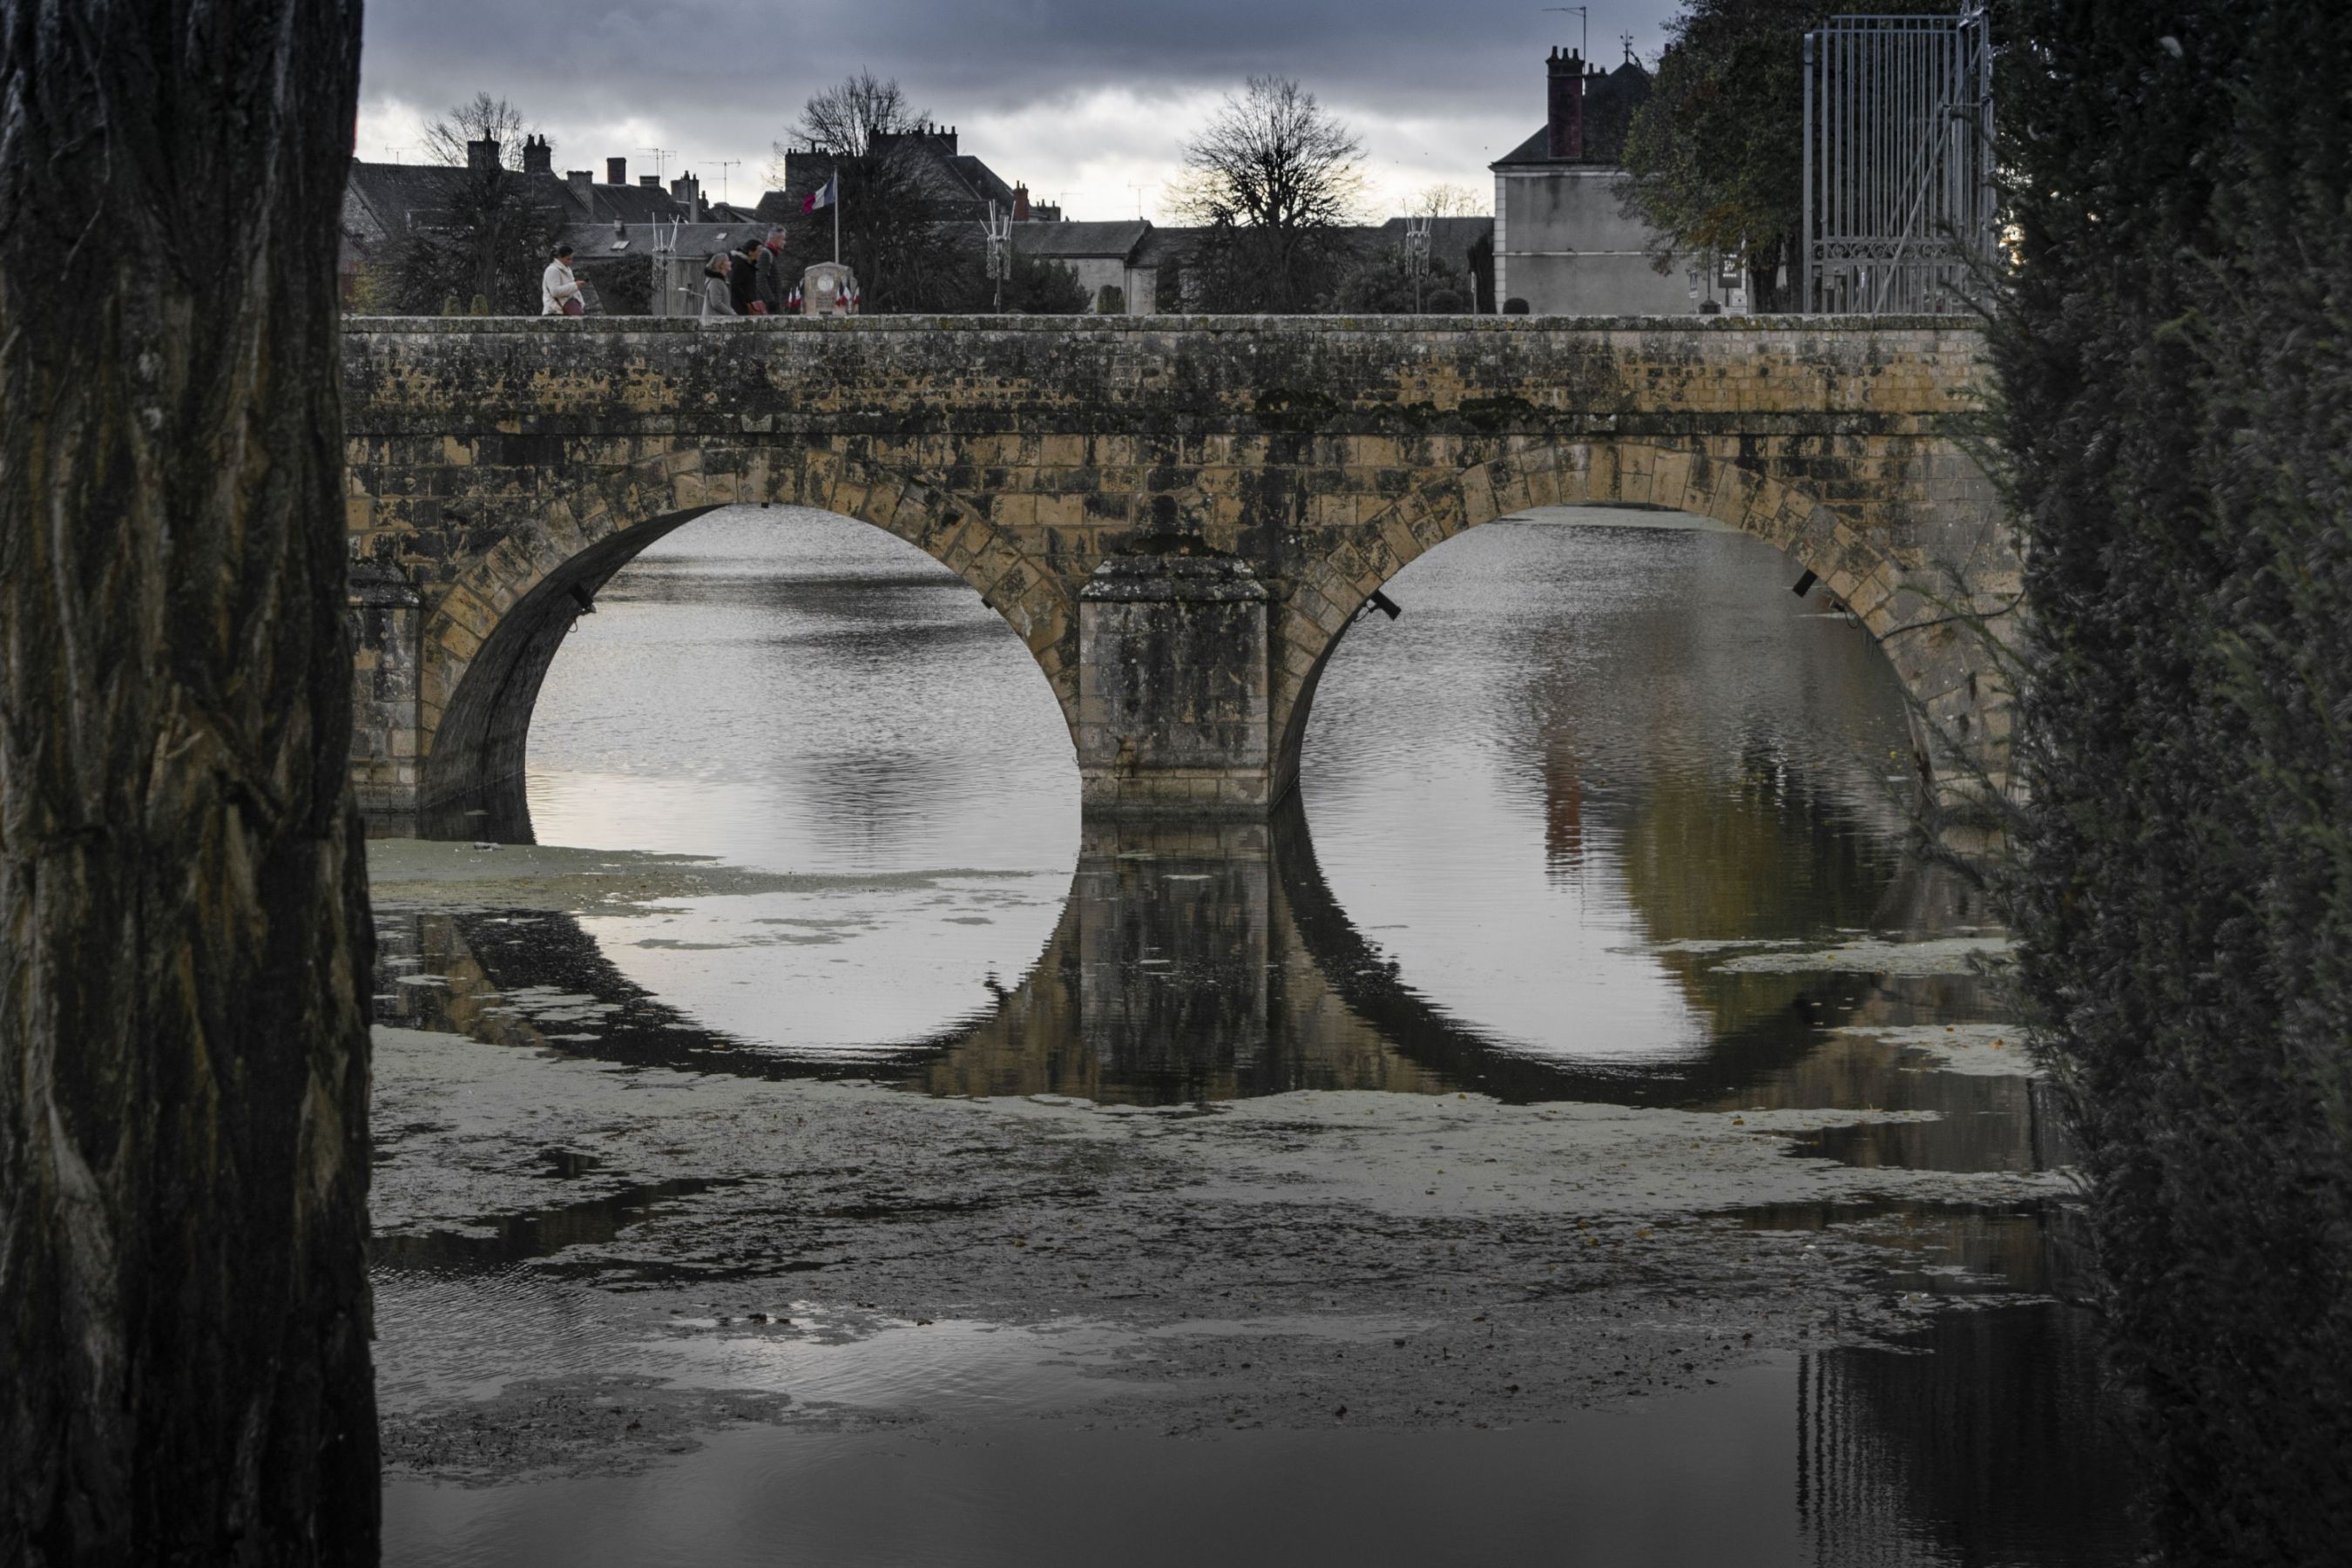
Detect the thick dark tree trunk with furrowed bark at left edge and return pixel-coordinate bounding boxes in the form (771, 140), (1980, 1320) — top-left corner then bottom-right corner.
(0, 0), (376, 1564)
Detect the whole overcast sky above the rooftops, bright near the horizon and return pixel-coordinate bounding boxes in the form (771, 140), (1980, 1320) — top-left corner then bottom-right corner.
(357, 0), (1680, 221)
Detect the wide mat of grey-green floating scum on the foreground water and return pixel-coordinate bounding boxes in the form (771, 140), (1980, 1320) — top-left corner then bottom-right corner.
(376, 1010), (2067, 1481)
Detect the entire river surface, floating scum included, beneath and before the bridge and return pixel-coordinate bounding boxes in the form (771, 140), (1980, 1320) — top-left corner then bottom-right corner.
(376, 508), (2131, 1564)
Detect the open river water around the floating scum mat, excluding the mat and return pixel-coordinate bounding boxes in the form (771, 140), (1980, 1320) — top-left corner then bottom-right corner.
(379, 508), (2131, 1565)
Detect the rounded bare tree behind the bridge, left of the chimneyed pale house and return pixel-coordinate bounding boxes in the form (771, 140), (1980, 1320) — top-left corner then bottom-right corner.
(1173, 75), (1364, 313)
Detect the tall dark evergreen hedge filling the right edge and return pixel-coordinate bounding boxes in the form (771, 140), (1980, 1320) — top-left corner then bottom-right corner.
(1997, 0), (2352, 1564)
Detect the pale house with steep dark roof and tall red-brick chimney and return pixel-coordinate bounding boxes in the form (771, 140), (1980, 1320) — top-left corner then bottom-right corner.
(1489, 50), (1724, 315)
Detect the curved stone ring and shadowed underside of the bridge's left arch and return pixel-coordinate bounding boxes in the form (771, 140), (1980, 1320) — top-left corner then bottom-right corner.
(416, 440), (1078, 811)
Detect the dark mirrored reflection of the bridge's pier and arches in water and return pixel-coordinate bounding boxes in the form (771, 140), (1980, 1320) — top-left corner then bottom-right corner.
(389, 800), (1957, 1105)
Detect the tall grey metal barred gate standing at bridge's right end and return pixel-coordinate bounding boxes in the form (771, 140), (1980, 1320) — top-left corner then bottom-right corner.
(1800, 4), (1997, 315)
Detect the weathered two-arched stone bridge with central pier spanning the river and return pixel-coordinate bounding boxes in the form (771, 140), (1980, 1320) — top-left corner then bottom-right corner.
(343, 317), (2018, 825)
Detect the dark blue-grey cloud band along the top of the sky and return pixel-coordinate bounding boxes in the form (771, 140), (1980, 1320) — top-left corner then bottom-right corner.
(362, 0), (1673, 151)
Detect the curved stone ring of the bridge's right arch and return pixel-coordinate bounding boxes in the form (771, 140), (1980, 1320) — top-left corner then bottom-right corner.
(1267, 437), (2009, 803)
